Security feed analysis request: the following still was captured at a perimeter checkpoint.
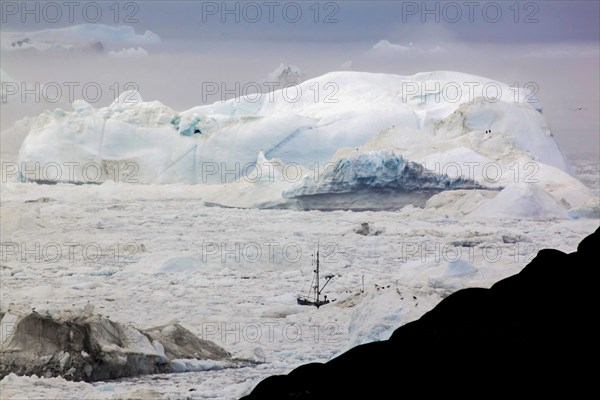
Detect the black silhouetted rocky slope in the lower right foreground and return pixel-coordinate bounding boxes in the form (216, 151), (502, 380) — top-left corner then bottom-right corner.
(244, 229), (600, 400)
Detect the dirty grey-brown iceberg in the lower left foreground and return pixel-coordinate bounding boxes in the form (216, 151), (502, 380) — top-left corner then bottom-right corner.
(0, 303), (231, 382)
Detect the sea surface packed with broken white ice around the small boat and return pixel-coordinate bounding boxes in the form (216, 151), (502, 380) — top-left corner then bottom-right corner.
(0, 159), (598, 399)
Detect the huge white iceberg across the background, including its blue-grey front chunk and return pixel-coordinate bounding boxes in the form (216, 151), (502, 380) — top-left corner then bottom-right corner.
(17, 71), (597, 218)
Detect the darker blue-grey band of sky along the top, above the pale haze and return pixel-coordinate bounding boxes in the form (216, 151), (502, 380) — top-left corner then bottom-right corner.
(2, 1), (600, 44)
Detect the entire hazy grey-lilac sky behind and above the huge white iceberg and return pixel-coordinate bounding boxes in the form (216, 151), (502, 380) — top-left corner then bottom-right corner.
(0, 1), (600, 158)
